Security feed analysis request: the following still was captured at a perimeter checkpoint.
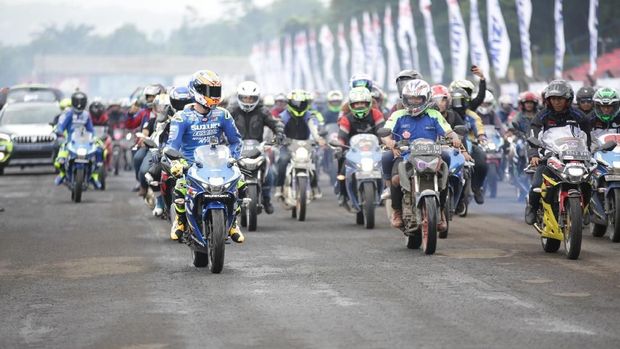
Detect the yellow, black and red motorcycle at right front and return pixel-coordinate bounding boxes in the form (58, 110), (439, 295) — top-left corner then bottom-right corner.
(528, 126), (596, 259)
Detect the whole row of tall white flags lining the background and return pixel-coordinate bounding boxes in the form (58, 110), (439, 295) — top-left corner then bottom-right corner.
(249, 0), (598, 93)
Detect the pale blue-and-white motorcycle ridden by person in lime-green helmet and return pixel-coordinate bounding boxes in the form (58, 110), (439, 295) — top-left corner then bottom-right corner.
(329, 133), (383, 229)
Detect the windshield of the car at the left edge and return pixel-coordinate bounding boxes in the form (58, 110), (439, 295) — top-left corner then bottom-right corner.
(0, 103), (60, 125)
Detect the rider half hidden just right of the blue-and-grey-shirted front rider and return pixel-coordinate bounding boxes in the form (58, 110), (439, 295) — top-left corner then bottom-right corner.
(450, 87), (488, 204)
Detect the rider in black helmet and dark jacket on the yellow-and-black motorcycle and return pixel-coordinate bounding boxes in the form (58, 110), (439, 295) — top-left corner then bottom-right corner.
(525, 80), (591, 225)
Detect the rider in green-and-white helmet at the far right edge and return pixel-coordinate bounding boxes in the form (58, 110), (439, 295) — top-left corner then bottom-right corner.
(591, 87), (620, 138)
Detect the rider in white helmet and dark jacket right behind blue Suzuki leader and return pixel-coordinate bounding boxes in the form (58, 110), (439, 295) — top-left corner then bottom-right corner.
(229, 81), (284, 214)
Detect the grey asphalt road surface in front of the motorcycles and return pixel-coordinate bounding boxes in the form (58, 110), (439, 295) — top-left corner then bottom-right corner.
(0, 170), (620, 349)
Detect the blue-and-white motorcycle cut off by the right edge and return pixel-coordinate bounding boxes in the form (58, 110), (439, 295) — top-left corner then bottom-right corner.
(590, 133), (620, 242)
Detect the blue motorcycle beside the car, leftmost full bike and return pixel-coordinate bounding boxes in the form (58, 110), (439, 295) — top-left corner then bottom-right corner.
(64, 128), (97, 203)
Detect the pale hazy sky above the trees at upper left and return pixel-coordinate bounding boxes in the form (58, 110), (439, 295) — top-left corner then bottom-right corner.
(0, 0), (294, 44)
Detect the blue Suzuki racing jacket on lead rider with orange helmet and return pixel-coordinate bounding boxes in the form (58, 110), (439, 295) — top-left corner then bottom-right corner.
(167, 107), (241, 162)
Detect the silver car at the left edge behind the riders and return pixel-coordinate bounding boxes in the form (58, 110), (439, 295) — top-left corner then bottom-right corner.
(0, 102), (61, 174)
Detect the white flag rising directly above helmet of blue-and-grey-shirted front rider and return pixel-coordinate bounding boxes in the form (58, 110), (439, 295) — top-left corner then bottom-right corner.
(398, 0), (420, 70)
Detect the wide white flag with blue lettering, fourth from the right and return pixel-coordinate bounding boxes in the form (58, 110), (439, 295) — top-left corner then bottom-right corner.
(487, 0), (510, 79)
